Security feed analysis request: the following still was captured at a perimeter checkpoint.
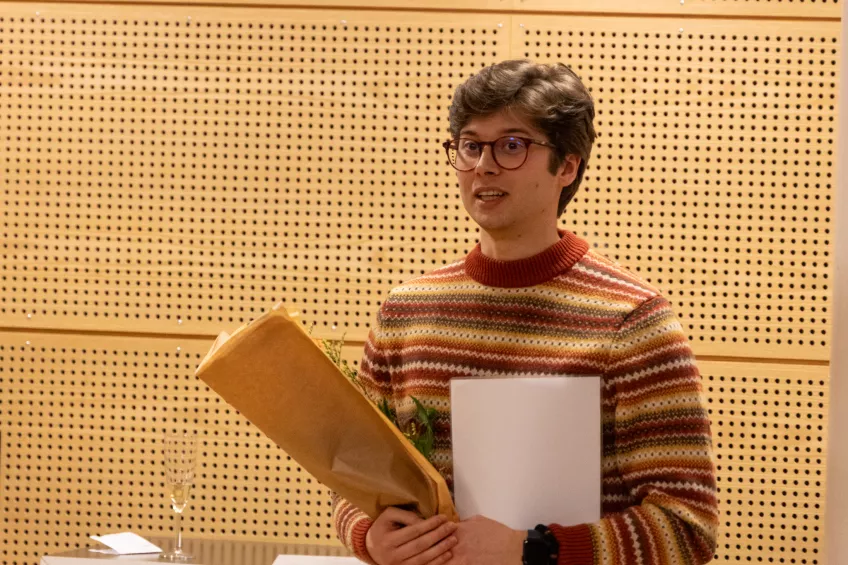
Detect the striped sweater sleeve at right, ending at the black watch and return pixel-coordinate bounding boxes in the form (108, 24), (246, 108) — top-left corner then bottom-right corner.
(549, 296), (718, 565)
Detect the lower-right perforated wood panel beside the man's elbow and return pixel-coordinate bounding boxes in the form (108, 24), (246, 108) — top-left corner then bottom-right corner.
(699, 361), (828, 564)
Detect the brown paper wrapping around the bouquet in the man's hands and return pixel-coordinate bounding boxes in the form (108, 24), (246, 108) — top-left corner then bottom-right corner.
(195, 305), (459, 521)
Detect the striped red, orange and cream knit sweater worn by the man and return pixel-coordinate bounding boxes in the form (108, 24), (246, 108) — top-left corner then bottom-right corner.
(333, 232), (718, 565)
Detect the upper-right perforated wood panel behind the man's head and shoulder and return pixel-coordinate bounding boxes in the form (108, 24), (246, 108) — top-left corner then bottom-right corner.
(512, 16), (839, 359)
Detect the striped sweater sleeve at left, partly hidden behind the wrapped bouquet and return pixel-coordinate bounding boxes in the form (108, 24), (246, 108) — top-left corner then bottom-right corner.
(330, 309), (392, 565)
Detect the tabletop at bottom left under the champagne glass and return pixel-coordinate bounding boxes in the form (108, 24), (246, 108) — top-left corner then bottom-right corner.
(41, 536), (351, 565)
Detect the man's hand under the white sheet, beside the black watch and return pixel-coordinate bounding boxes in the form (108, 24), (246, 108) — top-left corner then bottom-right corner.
(448, 516), (527, 565)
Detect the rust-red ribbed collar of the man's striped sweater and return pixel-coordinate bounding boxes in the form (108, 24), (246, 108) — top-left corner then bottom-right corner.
(465, 230), (589, 288)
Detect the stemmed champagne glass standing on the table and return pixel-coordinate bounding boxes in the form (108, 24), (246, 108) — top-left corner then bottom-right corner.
(159, 432), (197, 562)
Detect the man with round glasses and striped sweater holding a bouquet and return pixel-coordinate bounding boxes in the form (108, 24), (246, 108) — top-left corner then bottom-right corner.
(333, 61), (718, 565)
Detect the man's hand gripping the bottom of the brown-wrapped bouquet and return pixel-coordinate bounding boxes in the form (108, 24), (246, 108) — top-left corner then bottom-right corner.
(365, 508), (457, 565)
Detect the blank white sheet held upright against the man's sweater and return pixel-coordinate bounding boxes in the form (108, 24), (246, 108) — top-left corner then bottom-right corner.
(450, 376), (601, 530)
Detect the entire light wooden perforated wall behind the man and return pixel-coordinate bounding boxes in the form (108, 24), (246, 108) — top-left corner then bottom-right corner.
(0, 0), (841, 564)
